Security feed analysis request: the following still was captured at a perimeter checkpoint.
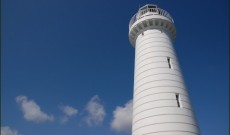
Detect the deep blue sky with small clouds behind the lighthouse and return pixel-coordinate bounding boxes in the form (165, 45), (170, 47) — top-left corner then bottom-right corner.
(1, 0), (229, 135)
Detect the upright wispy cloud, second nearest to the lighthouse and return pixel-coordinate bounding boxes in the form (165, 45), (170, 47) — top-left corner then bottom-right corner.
(85, 95), (106, 126)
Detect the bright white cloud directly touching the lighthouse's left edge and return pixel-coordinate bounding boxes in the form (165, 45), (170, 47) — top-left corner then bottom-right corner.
(111, 100), (133, 133)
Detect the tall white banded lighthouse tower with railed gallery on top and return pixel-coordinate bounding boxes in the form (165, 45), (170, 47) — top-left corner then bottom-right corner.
(129, 4), (200, 135)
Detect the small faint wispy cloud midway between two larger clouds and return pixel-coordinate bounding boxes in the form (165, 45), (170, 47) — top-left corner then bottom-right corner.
(60, 105), (78, 124)
